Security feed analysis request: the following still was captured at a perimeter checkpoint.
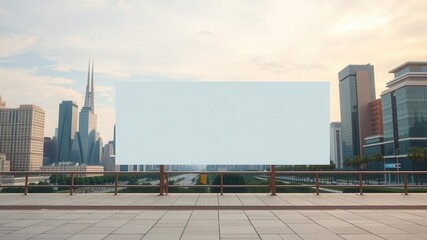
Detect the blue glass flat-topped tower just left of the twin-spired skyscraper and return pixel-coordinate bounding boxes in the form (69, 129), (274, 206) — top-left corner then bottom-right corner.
(55, 101), (78, 162)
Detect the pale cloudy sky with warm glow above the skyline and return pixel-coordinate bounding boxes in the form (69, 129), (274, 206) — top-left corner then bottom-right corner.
(0, 0), (427, 142)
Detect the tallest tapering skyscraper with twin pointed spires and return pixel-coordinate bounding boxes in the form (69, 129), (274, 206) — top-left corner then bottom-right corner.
(71, 63), (102, 165)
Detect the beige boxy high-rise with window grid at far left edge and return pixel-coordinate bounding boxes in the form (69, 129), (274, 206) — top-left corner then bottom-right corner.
(0, 99), (45, 171)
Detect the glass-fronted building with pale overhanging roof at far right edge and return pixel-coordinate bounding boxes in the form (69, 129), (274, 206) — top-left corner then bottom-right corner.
(381, 61), (427, 170)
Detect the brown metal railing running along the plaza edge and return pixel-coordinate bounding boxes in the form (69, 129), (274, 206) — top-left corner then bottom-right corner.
(0, 170), (427, 195)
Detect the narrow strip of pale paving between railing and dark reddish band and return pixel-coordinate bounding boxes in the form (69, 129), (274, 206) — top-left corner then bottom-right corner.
(0, 193), (427, 208)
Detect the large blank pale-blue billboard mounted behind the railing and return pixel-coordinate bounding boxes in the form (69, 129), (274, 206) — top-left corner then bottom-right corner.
(116, 81), (330, 165)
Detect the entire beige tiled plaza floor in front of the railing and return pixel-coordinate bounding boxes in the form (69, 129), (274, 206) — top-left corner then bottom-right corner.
(0, 193), (427, 240)
